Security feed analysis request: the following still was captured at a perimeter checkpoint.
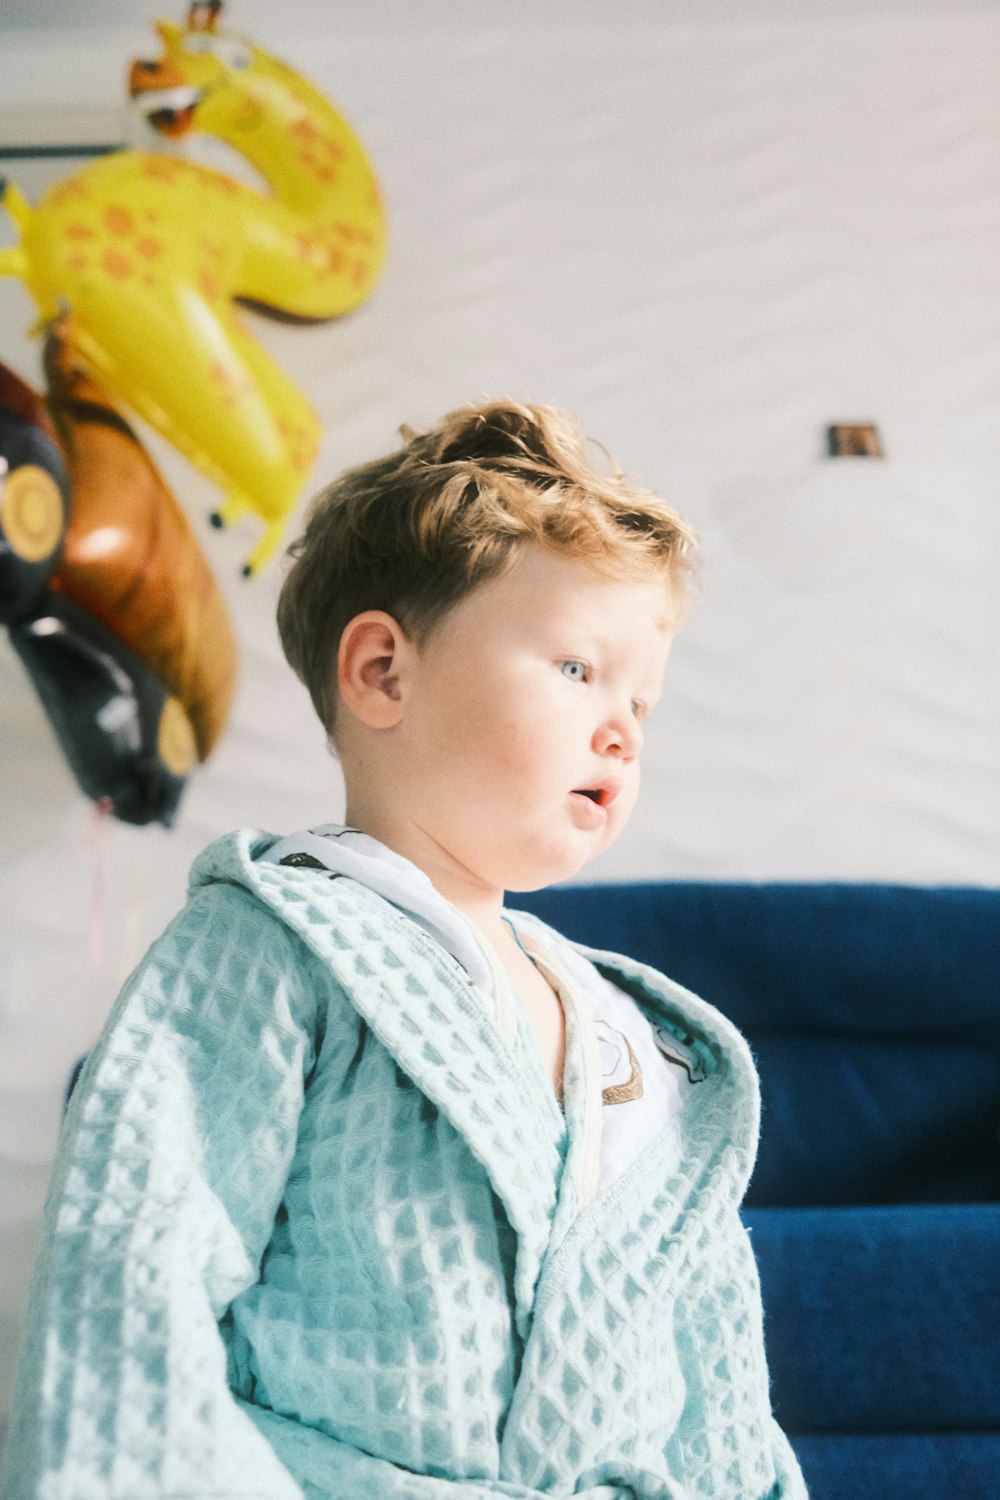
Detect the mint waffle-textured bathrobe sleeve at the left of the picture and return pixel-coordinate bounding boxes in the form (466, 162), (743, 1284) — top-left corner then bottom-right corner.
(3, 885), (322, 1500)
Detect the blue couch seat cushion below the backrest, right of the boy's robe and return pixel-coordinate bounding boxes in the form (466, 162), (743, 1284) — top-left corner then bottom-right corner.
(745, 1203), (1000, 1428)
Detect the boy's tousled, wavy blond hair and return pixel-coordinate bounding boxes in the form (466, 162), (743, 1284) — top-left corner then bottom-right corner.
(277, 401), (696, 734)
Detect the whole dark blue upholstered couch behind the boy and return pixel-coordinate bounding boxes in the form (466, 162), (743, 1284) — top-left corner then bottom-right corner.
(516, 884), (1000, 1500)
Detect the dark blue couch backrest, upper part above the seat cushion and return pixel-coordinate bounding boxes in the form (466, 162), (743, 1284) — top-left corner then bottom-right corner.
(510, 882), (1000, 1206)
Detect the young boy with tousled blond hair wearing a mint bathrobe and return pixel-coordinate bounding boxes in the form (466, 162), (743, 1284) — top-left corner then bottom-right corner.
(4, 404), (805, 1500)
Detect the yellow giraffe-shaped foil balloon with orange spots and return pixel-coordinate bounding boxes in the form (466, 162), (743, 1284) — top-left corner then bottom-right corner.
(0, 5), (385, 573)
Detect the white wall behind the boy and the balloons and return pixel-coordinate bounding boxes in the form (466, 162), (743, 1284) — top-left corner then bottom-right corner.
(0, 0), (1000, 1452)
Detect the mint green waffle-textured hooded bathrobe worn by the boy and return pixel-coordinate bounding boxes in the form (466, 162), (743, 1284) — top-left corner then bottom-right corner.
(3, 833), (805, 1500)
